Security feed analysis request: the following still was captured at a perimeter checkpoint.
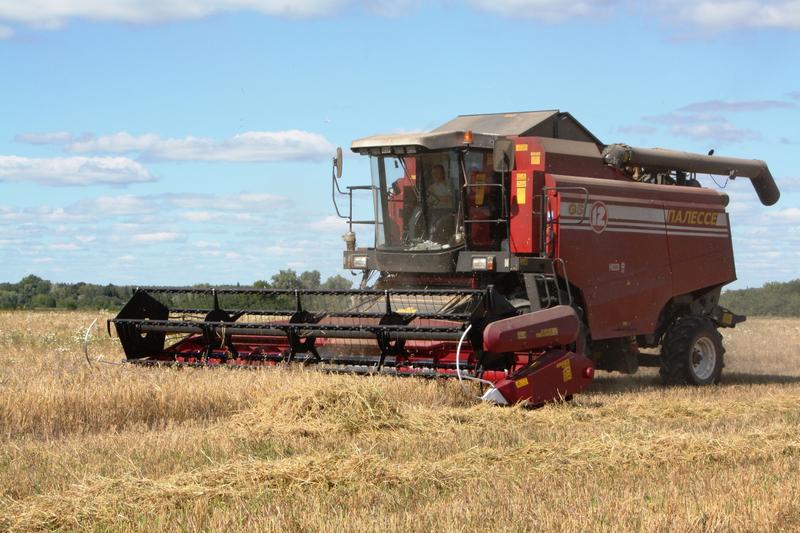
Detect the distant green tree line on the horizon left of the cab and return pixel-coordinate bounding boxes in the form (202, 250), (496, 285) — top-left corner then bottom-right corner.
(0, 269), (352, 310)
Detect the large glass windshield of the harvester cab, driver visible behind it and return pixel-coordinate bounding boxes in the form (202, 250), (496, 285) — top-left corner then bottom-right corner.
(371, 150), (499, 250)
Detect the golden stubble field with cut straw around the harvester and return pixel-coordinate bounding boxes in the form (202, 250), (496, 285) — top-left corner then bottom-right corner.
(0, 312), (800, 531)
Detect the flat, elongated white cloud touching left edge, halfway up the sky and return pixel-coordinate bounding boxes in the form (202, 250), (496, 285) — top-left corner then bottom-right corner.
(0, 155), (155, 185)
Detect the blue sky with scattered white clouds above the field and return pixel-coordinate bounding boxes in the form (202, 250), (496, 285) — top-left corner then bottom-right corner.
(0, 0), (800, 287)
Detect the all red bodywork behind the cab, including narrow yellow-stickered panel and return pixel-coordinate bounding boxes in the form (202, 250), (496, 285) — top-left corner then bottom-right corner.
(509, 137), (736, 340)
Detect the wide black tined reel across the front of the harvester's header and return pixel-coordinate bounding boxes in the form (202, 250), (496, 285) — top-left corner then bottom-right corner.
(108, 286), (502, 368)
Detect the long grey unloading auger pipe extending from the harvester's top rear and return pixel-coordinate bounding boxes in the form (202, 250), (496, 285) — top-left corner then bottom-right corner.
(603, 144), (781, 205)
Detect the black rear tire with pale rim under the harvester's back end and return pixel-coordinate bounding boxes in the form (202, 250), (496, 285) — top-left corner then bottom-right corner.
(660, 315), (725, 385)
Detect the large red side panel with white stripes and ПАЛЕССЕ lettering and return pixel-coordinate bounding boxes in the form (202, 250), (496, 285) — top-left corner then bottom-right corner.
(548, 175), (736, 340)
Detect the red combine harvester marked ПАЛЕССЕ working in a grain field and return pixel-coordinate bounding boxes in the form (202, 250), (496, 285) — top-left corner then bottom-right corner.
(110, 111), (780, 405)
